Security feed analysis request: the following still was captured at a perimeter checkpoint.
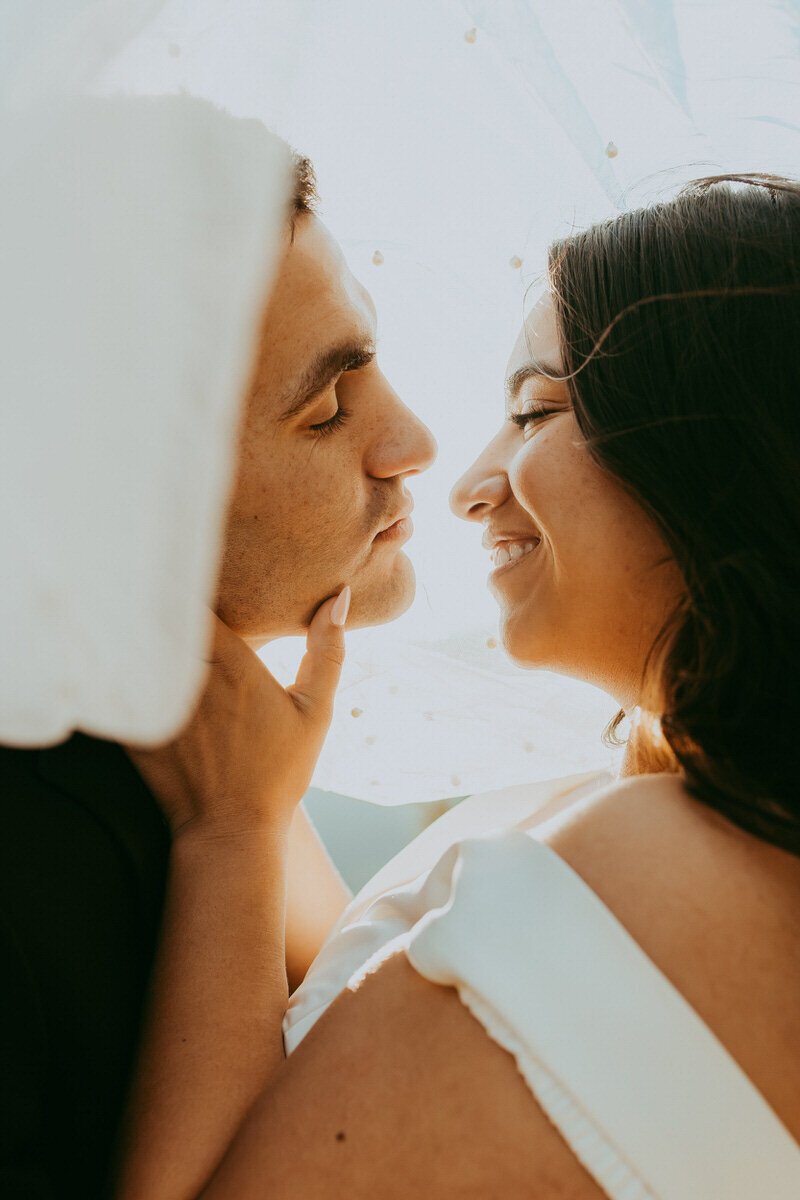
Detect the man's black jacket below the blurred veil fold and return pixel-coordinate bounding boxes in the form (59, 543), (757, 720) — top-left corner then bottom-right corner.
(0, 734), (169, 1200)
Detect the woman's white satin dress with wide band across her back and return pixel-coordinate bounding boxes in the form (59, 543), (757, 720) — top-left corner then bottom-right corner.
(284, 773), (800, 1200)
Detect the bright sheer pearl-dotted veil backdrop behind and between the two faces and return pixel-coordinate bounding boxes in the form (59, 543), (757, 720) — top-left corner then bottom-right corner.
(101, 0), (800, 804)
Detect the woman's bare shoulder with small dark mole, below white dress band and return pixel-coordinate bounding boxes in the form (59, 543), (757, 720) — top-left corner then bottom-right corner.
(203, 953), (604, 1200)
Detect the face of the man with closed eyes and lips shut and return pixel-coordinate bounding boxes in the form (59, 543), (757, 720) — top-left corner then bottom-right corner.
(217, 215), (437, 647)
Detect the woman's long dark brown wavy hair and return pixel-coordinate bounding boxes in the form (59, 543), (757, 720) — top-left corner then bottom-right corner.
(549, 175), (800, 853)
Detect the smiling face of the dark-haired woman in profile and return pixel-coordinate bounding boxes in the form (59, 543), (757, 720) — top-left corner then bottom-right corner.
(451, 292), (682, 708)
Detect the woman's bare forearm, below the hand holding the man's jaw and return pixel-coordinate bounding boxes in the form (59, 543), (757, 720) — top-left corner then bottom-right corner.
(115, 829), (288, 1200)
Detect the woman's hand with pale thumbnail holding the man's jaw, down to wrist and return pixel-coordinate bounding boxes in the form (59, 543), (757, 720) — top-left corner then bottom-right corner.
(126, 588), (350, 839)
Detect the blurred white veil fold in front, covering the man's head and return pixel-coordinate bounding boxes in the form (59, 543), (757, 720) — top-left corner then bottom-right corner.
(0, 0), (288, 745)
